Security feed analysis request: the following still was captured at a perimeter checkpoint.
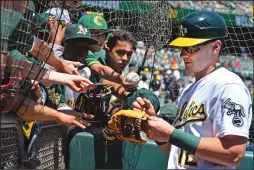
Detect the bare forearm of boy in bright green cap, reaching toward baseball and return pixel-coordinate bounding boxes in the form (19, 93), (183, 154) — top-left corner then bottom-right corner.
(91, 64), (122, 84)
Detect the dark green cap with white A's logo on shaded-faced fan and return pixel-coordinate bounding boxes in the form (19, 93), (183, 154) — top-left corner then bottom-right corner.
(65, 24), (98, 45)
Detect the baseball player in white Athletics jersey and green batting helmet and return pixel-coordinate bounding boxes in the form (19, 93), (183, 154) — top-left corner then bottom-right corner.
(133, 11), (252, 169)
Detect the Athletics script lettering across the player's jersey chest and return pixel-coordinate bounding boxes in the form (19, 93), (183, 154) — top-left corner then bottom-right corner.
(176, 101), (207, 129)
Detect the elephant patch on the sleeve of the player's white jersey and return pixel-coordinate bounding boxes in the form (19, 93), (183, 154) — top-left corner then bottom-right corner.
(221, 98), (245, 127)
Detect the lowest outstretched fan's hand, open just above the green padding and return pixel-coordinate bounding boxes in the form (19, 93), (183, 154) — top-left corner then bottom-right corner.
(56, 110), (94, 129)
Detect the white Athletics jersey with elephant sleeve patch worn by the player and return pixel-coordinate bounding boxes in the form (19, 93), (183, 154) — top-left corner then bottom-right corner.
(168, 68), (252, 169)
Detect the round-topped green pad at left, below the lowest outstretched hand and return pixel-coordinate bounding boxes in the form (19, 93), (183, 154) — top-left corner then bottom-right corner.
(70, 132), (95, 169)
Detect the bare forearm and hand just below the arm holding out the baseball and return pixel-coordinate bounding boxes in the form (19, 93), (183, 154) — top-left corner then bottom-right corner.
(102, 80), (129, 100)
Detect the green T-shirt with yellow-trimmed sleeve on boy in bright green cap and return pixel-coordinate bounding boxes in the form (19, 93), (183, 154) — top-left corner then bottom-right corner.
(85, 48), (107, 83)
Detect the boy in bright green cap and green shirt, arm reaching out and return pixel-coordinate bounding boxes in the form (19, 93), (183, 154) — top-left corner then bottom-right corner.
(78, 14), (134, 89)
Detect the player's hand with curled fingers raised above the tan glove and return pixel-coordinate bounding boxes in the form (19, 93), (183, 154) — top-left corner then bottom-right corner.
(133, 97), (156, 116)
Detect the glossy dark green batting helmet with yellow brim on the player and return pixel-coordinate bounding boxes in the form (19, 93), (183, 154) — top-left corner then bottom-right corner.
(169, 11), (227, 47)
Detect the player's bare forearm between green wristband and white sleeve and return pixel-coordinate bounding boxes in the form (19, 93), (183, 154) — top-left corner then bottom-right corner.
(195, 137), (246, 166)
